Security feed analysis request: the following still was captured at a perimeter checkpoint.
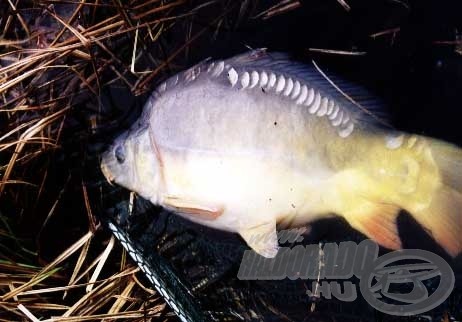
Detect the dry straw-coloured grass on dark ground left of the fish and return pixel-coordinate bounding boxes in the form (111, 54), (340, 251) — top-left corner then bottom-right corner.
(0, 0), (278, 321)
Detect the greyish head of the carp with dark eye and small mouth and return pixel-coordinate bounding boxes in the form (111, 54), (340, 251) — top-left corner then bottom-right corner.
(100, 128), (161, 204)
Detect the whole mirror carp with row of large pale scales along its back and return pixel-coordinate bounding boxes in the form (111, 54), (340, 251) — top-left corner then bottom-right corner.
(101, 49), (462, 258)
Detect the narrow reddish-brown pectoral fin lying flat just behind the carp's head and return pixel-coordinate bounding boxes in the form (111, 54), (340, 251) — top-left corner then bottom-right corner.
(164, 196), (224, 220)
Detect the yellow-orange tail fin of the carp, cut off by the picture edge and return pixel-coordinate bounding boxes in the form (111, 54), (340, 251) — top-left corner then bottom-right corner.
(408, 139), (462, 257)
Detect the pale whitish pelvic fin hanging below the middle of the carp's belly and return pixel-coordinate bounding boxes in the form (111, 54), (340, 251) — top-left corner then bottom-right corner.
(239, 221), (279, 258)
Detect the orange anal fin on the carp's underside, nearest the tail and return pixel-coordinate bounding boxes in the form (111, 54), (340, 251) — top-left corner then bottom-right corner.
(343, 202), (401, 249)
